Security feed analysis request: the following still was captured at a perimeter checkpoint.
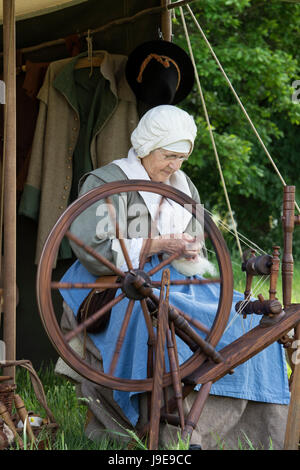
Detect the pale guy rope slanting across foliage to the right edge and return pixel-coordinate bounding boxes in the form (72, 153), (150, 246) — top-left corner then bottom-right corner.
(185, 5), (300, 213)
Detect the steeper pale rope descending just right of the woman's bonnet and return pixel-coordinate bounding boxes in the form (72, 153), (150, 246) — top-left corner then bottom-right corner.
(180, 7), (243, 258)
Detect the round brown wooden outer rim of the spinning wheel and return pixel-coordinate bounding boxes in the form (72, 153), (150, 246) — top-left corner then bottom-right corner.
(36, 180), (233, 392)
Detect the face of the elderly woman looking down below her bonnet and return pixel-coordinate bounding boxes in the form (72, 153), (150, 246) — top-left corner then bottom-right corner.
(141, 149), (189, 183)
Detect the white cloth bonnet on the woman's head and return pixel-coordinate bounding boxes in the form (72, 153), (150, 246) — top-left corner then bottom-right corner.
(131, 105), (197, 158)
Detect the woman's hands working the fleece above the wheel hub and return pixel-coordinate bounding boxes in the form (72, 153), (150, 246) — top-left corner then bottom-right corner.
(143, 233), (201, 261)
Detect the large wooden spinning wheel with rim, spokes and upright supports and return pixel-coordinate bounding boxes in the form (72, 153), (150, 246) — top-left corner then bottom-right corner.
(37, 180), (233, 446)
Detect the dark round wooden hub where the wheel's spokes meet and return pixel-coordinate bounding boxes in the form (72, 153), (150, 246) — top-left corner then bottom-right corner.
(122, 269), (152, 300)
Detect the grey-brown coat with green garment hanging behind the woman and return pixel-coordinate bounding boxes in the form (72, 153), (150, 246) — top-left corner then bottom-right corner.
(19, 51), (138, 263)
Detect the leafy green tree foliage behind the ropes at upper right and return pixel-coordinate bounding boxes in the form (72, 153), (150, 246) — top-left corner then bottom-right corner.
(173, 0), (300, 253)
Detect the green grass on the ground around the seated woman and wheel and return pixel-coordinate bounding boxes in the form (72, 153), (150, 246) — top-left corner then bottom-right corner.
(4, 260), (300, 450)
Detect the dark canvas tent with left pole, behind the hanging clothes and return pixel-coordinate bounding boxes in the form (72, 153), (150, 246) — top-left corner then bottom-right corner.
(0, 0), (170, 367)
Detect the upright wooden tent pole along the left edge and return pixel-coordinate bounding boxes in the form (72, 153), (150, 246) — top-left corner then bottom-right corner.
(3, 0), (16, 381)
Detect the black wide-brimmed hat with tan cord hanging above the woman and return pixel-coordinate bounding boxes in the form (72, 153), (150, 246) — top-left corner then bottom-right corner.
(126, 39), (195, 106)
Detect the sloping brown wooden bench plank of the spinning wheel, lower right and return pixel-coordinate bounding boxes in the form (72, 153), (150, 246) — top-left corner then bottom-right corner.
(183, 304), (300, 385)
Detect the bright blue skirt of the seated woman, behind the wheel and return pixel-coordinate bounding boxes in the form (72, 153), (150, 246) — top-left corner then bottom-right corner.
(60, 256), (290, 426)
